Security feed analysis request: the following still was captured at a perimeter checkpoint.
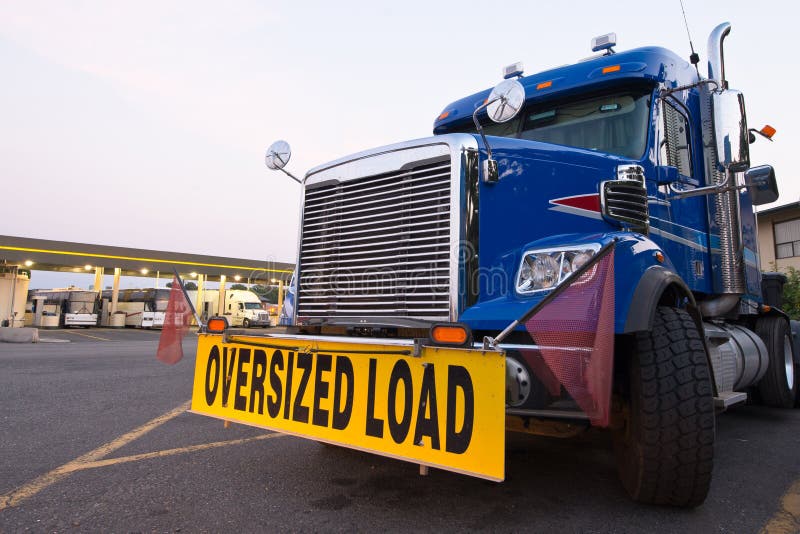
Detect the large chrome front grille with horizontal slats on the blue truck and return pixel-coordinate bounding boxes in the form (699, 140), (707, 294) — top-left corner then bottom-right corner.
(297, 154), (454, 322)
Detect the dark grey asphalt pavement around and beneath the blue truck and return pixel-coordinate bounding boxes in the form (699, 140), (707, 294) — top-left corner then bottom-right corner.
(0, 328), (800, 533)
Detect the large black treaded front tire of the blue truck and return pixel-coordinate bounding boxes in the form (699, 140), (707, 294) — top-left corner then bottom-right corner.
(614, 307), (714, 507)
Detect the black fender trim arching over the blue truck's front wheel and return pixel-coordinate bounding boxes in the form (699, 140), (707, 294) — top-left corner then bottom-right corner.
(624, 265), (702, 334)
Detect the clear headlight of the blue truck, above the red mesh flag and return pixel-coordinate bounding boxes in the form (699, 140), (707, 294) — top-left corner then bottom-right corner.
(517, 243), (600, 294)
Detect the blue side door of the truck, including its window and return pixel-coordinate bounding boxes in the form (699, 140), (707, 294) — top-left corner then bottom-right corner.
(649, 97), (711, 292)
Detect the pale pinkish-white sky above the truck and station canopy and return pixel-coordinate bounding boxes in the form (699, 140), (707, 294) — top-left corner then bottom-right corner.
(0, 0), (800, 288)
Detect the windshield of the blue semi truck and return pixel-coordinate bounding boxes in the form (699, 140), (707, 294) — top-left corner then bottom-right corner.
(459, 89), (651, 159)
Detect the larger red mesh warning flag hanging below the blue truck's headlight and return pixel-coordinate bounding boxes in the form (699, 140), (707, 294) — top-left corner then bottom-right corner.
(524, 249), (614, 426)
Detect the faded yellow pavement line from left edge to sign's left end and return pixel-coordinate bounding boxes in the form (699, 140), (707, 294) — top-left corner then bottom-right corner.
(0, 401), (191, 511)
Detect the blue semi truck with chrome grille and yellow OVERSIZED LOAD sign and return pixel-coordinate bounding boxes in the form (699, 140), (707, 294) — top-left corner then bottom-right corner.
(192, 23), (797, 506)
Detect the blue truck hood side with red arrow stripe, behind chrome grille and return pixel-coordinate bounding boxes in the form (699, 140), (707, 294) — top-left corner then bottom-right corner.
(478, 137), (636, 301)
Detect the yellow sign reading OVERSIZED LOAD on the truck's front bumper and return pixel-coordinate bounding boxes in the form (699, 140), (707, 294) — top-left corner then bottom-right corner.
(192, 335), (505, 481)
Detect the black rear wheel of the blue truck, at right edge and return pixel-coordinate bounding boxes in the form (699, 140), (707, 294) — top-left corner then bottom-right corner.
(756, 317), (797, 408)
